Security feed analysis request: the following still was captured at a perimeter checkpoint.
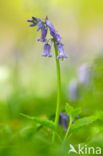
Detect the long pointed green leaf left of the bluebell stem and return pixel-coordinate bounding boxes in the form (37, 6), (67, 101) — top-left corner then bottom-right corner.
(20, 113), (56, 131)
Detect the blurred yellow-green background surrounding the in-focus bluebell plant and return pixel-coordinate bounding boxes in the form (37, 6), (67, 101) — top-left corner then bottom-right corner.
(0, 0), (103, 156)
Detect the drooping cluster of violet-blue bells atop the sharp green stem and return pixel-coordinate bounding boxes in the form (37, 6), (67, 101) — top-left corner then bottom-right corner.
(27, 17), (67, 60)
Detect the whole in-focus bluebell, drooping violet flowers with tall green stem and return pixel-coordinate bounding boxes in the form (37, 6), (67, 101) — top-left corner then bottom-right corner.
(27, 16), (67, 142)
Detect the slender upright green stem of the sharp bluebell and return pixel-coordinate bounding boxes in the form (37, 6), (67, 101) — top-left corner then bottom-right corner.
(52, 40), (61, 142)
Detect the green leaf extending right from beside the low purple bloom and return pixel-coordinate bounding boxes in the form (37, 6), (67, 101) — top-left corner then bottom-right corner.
(71, 116), (98, 132)
